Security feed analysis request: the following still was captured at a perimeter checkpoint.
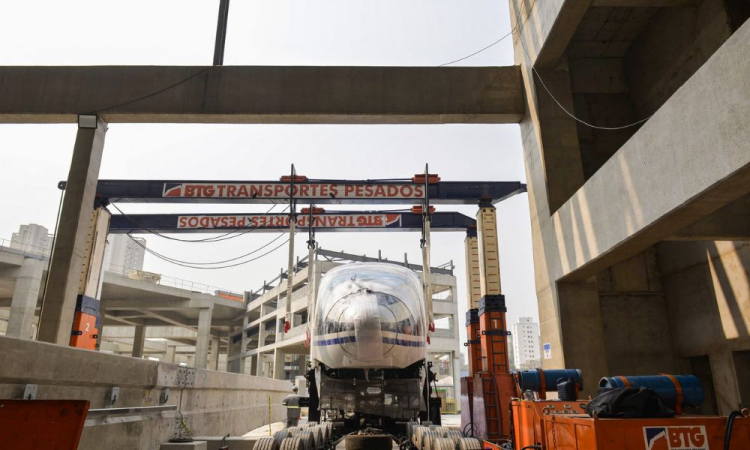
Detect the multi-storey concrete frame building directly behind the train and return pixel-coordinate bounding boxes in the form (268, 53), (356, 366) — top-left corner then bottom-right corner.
(228, 249), (461, 400)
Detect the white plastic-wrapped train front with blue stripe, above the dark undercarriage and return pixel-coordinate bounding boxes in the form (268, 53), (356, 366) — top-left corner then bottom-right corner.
(311, 263), (427, 369)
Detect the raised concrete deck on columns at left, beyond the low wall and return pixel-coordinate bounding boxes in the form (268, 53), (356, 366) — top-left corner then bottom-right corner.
(0, 241), (245, 369)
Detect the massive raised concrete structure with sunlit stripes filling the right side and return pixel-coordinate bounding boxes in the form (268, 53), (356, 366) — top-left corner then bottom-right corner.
(510, 0), (750, 413)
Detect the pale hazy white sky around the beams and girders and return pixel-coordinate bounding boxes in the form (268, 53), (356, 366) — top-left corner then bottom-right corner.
(0, 0), (537, 344)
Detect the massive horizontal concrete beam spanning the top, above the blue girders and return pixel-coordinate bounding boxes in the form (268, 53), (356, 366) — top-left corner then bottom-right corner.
(0, 66), (524, 124)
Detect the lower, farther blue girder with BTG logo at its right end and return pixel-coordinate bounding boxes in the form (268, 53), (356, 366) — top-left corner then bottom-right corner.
(109, 211), (476, 234)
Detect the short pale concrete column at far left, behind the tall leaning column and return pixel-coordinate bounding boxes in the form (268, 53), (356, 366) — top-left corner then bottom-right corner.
(5, 258), (44, 339)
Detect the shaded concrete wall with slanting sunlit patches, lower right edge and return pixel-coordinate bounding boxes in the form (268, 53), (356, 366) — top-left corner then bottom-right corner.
(658, 241), (750, 414)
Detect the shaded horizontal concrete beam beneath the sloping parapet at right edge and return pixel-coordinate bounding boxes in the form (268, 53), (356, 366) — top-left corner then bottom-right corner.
(670, 195), (750, 241)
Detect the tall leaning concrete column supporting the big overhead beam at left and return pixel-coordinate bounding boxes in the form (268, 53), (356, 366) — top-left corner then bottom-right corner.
(38, 119), (107, 345)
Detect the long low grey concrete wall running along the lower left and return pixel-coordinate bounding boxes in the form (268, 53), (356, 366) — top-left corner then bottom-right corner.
(0, 337), (289, 450)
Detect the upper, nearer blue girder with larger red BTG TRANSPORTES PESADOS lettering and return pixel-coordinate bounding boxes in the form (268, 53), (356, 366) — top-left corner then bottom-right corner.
(97, 180), (526, 205)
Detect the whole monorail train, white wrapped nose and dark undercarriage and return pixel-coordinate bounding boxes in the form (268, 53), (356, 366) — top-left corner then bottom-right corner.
(308, 263), (439, 423)
